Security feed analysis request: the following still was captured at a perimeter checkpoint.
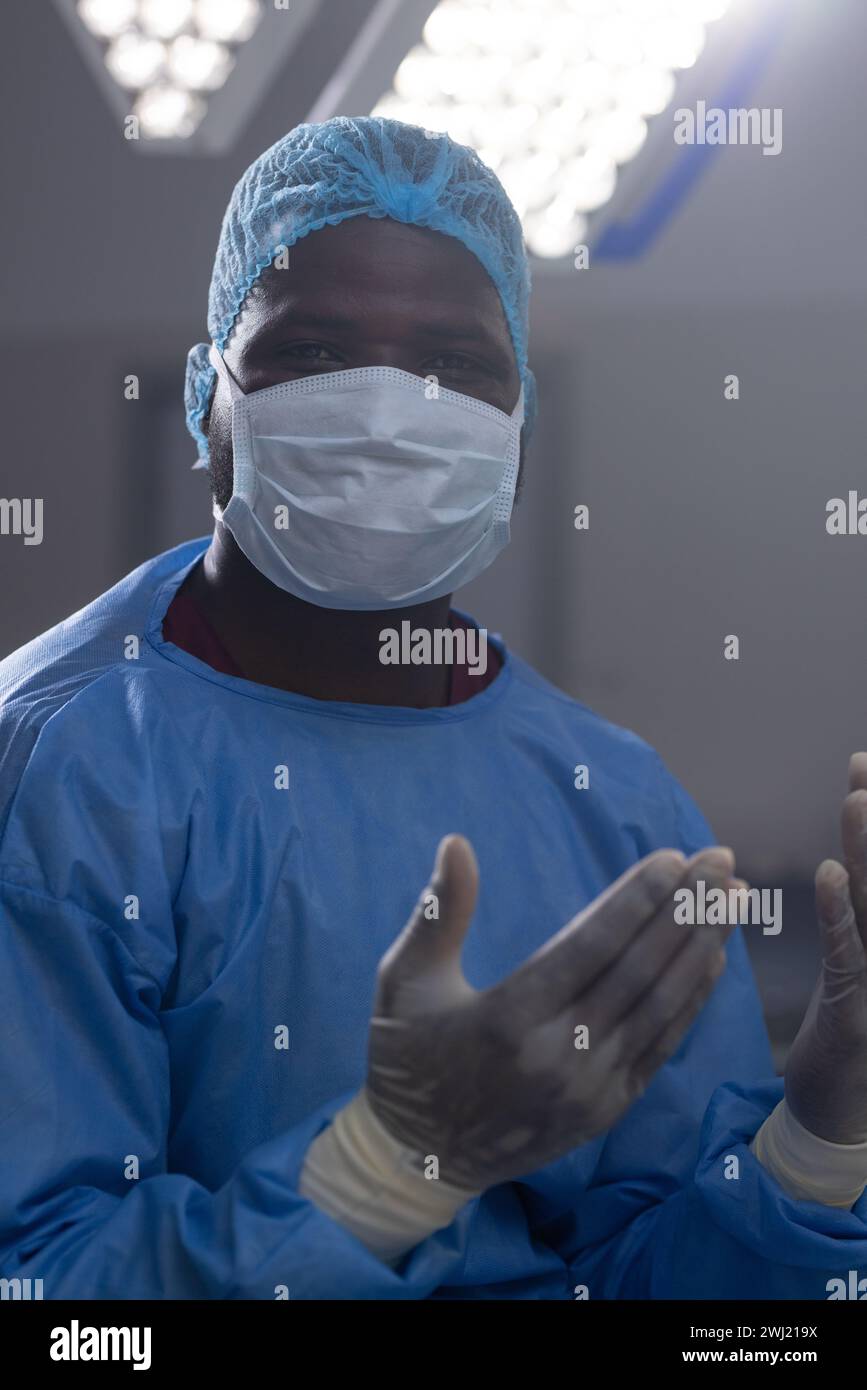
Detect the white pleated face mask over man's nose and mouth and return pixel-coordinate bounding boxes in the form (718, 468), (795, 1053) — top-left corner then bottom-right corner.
(210, 348), (524, 609)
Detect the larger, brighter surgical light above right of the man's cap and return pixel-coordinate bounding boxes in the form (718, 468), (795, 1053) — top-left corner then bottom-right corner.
(374, 0), (729, 259)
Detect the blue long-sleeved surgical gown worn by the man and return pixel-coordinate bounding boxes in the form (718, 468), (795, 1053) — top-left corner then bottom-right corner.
(0, 541), (867, 1300)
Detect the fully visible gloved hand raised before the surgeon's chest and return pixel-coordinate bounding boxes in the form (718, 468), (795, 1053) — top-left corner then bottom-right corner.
(367, 835), (734, 1191)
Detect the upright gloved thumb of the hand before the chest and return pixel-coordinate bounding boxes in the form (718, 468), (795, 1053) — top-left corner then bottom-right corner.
(381, 835), (478, 984)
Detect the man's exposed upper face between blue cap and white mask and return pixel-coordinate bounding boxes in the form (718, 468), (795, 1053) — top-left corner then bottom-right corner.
(207, 217), (521, 506)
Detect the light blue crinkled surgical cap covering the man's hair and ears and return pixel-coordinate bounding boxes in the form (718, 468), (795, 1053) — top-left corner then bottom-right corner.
(185, 115), (536, 466)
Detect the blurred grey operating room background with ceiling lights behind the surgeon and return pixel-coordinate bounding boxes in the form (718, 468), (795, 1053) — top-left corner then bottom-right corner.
(0, 0), (867, 1061)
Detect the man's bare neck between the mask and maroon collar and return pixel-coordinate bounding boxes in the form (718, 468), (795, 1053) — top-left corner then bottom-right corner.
(183, 521), (450, 709)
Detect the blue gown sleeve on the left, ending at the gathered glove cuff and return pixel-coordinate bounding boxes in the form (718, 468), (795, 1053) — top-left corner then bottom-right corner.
(0, 883), (500, 1300)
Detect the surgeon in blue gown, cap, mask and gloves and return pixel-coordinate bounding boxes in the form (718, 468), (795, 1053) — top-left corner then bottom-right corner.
(0, 118), (867, 1300)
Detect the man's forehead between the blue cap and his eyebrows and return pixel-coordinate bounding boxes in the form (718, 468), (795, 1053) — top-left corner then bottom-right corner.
(236, 215), (511, 343)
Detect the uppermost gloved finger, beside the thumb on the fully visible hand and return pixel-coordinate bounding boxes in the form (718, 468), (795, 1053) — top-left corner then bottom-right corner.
(502, 849), (686, 1015)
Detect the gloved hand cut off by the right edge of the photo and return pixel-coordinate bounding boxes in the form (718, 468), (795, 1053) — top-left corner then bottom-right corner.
(785, 753), (867, 1144)
